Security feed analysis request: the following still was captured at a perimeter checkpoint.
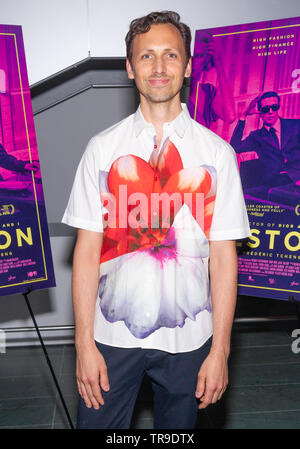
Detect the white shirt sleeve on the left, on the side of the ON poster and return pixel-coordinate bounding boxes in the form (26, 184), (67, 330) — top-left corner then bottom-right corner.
(62, 138), (103, 232)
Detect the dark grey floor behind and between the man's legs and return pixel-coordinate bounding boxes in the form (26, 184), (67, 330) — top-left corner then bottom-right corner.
(0, 297), (300, 429)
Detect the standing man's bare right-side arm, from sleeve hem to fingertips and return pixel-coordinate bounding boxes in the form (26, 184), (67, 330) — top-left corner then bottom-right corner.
(196, 240), (237, 409)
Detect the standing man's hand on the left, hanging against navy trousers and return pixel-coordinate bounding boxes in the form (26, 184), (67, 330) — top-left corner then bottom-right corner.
(76, 345), (109, 410)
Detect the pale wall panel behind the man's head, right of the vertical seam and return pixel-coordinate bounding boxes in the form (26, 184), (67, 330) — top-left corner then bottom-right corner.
(89, 0), (300, 56)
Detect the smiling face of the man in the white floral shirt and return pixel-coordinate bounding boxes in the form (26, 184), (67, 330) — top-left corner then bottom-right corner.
(126, 24), (191, 103)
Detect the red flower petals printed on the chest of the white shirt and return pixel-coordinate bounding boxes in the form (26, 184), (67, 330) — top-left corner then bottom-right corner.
(100, 139), (216, 263)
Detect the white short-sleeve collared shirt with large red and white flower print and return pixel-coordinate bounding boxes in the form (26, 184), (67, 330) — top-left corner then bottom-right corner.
(62, 105), (250, 353)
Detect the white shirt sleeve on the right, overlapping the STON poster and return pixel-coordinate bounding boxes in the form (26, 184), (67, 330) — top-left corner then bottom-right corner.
(209, 142), (250, 240)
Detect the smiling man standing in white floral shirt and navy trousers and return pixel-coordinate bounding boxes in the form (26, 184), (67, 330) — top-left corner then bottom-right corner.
(63, 11), (249, 429)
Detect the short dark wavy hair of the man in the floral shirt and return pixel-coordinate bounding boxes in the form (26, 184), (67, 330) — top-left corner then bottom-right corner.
(125, 11), (192, 63)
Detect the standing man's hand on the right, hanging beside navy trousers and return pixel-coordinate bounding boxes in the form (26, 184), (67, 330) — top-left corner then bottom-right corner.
(196, 352), (228, 409)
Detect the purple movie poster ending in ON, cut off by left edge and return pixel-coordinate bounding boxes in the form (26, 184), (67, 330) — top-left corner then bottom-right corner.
(0, 25), (55, 296)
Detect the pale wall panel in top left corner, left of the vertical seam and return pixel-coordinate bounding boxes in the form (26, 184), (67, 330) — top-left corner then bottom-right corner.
(0, 0), (88, 84)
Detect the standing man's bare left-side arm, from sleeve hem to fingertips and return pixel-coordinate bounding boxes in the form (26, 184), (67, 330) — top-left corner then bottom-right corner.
(72, 229), (109, 409)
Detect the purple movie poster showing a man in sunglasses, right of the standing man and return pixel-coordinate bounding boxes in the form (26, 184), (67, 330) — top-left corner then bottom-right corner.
(189, 17), (300, 300)
